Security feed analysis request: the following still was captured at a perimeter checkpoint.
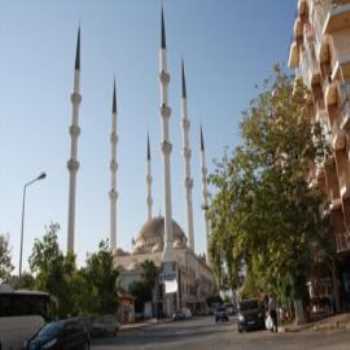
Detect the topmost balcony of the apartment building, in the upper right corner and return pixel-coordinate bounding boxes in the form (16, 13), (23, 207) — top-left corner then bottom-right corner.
(323, 0), (350, 34)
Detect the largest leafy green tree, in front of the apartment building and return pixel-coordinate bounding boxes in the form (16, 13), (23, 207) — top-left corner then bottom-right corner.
(209, 67), (334, 324)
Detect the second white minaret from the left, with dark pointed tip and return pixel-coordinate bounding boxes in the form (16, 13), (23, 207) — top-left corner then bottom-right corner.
(109, 80), (118, 251)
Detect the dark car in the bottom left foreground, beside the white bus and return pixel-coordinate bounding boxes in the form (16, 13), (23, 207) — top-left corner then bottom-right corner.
(24, 319), (90, 350)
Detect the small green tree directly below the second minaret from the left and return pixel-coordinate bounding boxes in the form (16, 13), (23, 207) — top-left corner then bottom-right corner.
(81, 241), (119, 314)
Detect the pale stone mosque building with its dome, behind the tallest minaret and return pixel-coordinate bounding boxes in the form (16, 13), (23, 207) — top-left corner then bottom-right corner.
(116, 216), (215, 316)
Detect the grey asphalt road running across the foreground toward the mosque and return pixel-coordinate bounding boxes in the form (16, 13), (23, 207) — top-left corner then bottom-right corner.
(92, 317), (350, 350)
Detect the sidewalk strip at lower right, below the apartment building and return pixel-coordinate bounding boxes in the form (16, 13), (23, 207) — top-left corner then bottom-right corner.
(279, 313), (350, 333)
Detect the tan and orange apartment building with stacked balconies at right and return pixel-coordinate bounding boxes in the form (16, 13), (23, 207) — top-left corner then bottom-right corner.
(289, 0), (350, 305)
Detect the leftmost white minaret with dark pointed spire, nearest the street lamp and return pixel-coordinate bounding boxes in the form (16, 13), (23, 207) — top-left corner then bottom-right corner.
(67, 27), (81, 253)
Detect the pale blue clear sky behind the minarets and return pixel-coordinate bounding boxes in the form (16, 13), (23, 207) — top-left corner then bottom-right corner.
(0, 0), (296, 266)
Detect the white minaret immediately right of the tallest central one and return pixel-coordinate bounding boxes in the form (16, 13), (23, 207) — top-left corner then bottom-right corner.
(181, 61), (195, 251)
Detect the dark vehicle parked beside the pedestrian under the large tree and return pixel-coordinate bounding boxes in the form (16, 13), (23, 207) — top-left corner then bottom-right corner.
(238, 299), (265, 332)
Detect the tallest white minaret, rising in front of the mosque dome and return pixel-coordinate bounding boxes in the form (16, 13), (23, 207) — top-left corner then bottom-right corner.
(159, 7), (173, 262)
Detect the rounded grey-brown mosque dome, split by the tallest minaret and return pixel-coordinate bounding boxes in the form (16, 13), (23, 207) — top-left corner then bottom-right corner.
(133, 216), (187, 254)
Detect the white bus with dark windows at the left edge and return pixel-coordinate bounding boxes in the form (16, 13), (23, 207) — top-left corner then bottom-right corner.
(0, 285), (52, 350)
